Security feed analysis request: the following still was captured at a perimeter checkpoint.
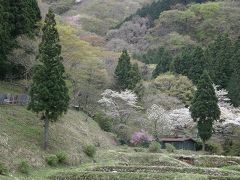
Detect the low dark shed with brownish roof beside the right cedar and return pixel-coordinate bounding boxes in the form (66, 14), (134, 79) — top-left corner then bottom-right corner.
(159, 137), (197, 151)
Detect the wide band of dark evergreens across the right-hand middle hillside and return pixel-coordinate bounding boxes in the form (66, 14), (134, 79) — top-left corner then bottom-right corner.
(142, 34), (240, 106)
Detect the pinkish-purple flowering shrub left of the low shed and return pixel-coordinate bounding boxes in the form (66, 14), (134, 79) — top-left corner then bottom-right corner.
(130, 130), (153, 147)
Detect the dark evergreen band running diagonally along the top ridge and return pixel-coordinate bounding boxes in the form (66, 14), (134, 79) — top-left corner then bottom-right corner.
(115, 0), (211, 28)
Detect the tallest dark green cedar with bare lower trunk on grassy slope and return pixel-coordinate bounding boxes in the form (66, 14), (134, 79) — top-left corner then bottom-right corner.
(29, 9), (69, 150)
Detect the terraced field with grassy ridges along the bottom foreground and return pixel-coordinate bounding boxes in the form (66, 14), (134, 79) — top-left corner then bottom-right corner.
(50, 150), (240, 180)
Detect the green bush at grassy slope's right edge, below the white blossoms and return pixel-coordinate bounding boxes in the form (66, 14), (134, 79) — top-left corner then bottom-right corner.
(94, 113), (113, 132)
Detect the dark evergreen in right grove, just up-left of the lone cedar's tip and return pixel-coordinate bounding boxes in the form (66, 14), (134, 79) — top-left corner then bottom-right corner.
(188, 47), (208, 85)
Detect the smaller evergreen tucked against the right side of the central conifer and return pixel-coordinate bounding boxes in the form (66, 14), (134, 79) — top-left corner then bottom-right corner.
(128, 63), (142, 90)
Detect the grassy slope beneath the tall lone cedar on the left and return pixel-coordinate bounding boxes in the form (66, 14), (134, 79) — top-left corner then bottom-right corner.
(0, 83), (112, 169)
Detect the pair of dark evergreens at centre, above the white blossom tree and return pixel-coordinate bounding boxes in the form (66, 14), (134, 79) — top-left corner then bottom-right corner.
(114, 50), (141, 90)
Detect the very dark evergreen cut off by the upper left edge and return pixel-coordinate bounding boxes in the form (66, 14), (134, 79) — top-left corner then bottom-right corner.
(0, 0), (12, 79)
